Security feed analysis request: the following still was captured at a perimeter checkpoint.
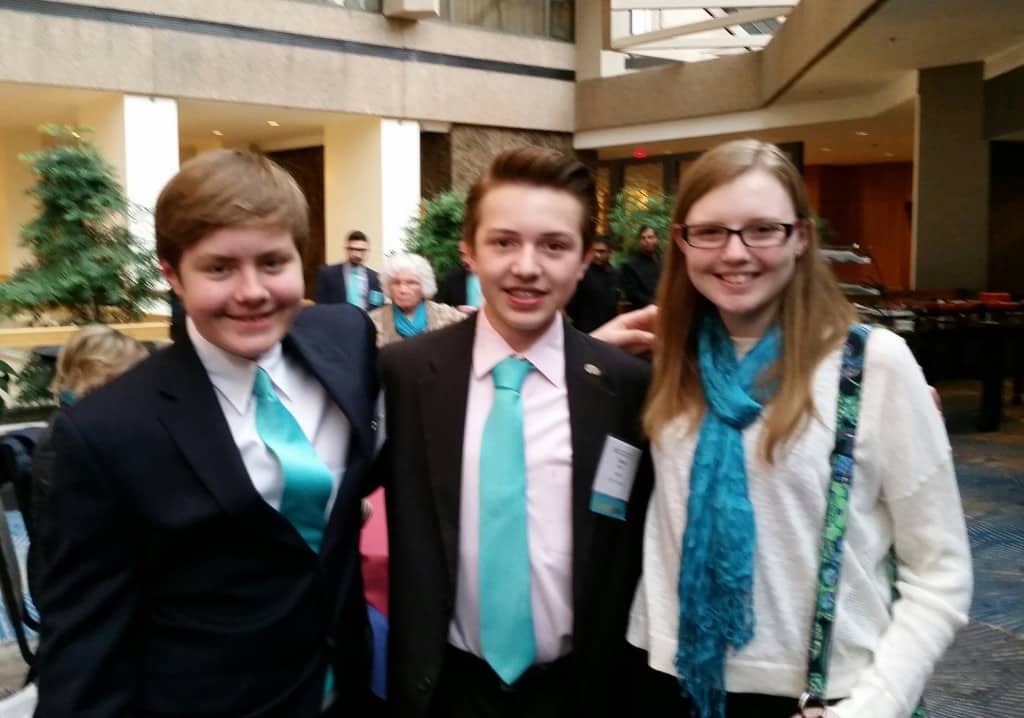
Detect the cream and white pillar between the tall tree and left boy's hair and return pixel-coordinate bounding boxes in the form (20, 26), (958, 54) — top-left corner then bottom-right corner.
(78, 95), (179, 252)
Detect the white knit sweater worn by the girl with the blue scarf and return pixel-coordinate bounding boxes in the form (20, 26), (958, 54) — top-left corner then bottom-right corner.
(628, 329), (972, 718)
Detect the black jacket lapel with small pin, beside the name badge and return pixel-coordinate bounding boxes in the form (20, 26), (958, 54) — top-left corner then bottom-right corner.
(565, 324), (615, 603)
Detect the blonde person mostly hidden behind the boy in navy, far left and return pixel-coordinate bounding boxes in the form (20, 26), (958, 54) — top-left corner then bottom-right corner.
(28, 325), (150, 596)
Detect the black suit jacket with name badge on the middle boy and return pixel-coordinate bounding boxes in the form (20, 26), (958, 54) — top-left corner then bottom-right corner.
(381, 316), (651, 718)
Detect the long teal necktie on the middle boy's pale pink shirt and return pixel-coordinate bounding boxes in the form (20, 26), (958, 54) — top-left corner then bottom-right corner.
(479, 356), (537, 684)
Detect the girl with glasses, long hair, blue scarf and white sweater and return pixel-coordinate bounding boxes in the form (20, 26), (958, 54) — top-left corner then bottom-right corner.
(628, 139), (972, 718)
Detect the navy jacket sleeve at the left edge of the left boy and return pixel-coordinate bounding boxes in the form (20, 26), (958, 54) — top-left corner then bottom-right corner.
(36, 414), (142, 718)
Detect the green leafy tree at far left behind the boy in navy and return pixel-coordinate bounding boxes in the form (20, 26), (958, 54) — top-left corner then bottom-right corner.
(0, 125), (159, 324)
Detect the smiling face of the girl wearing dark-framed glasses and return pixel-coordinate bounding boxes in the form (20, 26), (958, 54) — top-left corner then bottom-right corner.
(673, 169), (807, 338)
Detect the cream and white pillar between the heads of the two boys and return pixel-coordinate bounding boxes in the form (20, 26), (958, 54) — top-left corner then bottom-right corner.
(324, 117), (420, 267)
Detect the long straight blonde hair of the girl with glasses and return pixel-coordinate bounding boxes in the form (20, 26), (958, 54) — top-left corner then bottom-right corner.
(644, 139), (856, 463)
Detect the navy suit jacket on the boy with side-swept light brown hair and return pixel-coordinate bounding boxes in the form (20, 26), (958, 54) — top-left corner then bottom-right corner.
(36, 304), (378, 718)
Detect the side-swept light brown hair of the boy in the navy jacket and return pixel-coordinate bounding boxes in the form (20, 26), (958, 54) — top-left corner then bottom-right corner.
(154, 150), (309, 269)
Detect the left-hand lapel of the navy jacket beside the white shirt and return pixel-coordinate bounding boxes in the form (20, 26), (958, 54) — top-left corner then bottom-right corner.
(151, 338), (308, 551)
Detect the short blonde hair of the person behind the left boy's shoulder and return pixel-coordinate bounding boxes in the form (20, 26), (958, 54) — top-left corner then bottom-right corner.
(52, 325), (150, 397)
